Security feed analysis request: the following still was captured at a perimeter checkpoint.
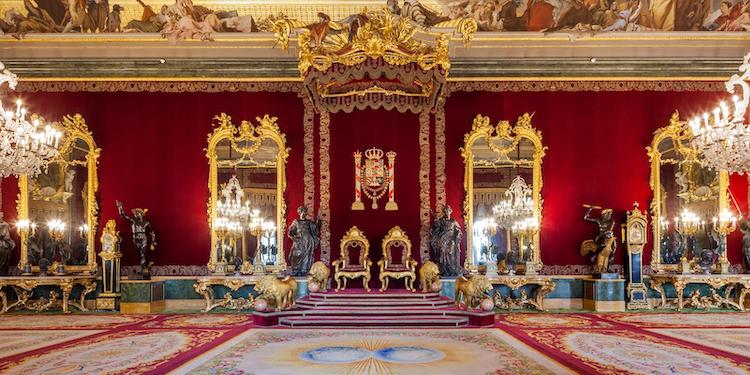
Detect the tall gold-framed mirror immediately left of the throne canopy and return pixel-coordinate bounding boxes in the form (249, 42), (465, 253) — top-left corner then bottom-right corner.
(206, 113), (289, 274)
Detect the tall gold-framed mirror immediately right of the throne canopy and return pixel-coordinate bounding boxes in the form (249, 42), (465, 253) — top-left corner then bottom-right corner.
(461, 113), (545, 273)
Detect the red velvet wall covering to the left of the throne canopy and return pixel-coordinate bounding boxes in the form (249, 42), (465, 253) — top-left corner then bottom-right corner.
(3, 92), (303, 265)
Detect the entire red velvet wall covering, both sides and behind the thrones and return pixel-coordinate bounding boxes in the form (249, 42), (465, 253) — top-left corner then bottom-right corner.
(2, 91), (748, 265)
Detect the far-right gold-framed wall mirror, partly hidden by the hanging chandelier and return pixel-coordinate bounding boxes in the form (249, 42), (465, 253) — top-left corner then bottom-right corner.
(647, 113), (729, 272)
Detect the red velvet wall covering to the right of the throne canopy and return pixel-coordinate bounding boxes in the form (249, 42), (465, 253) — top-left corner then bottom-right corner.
(445, 92), (747, 265)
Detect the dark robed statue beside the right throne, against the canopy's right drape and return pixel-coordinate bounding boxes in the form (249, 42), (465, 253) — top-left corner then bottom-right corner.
(430, 206), (463, 276)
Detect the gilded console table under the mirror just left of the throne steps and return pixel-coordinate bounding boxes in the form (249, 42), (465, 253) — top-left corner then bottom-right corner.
(193, 276), (258, 312)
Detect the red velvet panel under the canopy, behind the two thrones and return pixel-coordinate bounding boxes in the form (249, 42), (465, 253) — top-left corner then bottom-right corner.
(330, 110), (420, 263)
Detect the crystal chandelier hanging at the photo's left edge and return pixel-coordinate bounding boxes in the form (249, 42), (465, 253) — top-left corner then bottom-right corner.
(0, 63), (62, 177)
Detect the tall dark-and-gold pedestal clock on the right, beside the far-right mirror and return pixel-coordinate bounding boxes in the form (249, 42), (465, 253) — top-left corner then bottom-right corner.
(622, 202), (651, 310)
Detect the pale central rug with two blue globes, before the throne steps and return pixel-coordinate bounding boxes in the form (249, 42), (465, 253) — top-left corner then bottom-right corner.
(176, 329), (570, 375)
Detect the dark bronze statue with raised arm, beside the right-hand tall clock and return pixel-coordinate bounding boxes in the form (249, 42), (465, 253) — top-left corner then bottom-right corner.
(581, 205), (617, 274)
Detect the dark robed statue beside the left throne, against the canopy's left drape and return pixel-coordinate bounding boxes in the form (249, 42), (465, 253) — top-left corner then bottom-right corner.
(288, 206), (323, 276)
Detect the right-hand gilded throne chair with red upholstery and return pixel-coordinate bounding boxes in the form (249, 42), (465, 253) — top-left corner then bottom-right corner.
(378, 226), (417, 292)
